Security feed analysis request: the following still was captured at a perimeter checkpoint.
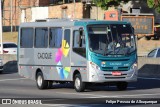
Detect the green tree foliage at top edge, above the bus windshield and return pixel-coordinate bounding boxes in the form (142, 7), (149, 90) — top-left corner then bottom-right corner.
(92, 0), (129, 10)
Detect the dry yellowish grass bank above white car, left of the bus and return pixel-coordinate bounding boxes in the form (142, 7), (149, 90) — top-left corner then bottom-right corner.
(3, 32), (18, 43)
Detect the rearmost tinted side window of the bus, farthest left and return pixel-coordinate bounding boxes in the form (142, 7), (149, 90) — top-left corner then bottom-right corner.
(20, 28), (33, 48)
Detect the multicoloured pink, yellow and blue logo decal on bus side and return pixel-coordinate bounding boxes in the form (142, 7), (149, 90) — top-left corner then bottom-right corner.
(55, 40), (71, 79)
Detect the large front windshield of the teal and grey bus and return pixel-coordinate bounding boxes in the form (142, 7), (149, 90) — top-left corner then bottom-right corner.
(88, 24), (136, 55)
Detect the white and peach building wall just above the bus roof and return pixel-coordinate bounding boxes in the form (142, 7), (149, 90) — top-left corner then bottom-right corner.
(21, 3), (85, 22)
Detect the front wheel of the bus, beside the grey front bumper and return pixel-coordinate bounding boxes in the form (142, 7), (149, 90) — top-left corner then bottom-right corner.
(74, 74), (85, 92)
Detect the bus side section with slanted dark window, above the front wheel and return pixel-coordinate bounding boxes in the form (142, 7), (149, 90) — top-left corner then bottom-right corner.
(71, 27), (87, 66)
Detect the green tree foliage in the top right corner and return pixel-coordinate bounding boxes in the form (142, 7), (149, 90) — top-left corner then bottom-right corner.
(147, 0), (160, 13)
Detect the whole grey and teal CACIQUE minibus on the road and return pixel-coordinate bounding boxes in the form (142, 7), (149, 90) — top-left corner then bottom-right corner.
(18, 20), (137, 92)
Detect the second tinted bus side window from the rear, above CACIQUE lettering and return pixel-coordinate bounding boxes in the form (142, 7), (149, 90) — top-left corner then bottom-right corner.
(35, 28), (48, 48)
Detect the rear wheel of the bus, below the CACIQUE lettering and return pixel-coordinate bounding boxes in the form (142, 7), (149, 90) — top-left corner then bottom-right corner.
(36, 72), (48, 89)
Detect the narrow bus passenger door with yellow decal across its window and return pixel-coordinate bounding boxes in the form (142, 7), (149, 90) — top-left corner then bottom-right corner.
(61, 28), (71, 69)
